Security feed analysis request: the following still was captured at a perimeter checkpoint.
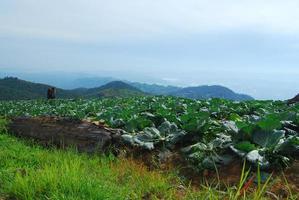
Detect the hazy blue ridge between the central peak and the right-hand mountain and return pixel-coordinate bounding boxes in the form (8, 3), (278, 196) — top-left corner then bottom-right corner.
(128, 82), (182, 95)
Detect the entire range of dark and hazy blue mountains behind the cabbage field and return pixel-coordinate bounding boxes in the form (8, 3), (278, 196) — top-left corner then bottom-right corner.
(0, 77), (253, 101)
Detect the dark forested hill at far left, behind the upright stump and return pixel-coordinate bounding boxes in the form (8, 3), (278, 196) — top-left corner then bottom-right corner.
(0, 77), (79, 100)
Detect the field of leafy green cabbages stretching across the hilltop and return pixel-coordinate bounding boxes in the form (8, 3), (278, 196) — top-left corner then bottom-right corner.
(0, 96), (299, 170)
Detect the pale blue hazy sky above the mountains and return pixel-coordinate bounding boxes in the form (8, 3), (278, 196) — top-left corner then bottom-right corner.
(0, 0), (299, 99)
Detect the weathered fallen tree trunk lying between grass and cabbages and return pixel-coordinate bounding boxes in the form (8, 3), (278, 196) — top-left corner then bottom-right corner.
(9, 117), (121, 153)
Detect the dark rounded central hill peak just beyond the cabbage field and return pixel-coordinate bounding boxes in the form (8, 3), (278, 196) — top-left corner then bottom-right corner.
(85, 81), (145, 97)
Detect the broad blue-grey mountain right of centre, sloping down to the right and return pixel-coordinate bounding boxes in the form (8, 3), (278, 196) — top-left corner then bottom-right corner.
(169, 85), (253, 101)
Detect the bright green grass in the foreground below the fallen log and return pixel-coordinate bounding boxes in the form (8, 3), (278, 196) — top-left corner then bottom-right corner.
(0, 130), (298, 200)
